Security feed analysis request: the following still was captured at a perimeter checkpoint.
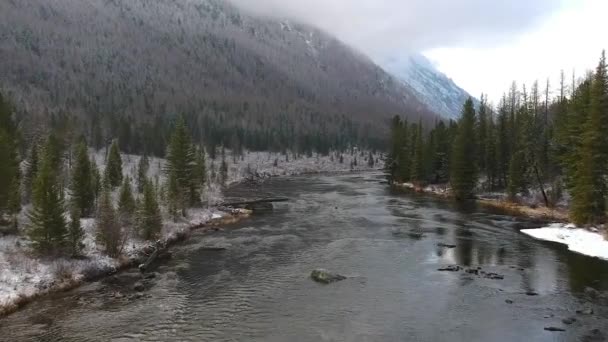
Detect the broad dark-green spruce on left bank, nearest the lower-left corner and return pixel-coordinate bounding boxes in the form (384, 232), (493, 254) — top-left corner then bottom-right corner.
(28, 141), (67, 254)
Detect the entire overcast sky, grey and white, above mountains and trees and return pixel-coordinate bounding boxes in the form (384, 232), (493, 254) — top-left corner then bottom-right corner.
(233, 0), (608, 100)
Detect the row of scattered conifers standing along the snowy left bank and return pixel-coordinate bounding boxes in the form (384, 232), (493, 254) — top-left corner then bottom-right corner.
(0, 95), (213, 257)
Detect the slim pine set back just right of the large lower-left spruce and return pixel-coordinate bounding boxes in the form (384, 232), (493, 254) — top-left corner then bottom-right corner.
(70, 141), (95, 217)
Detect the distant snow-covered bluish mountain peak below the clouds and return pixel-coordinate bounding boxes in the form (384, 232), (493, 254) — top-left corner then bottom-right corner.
(382, 54), (477, 119)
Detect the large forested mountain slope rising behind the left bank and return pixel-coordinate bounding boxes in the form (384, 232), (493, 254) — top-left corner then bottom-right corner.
(0, 0), (437, 153)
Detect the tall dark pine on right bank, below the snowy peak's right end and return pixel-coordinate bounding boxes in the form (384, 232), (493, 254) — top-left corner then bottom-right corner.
(450, 98), (477, 200)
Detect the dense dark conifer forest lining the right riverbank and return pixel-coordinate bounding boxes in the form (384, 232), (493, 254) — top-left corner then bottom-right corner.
(386, 52), (608, 224)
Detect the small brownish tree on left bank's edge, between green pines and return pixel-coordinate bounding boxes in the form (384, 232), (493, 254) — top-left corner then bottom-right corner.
(97, 189), (125, 258)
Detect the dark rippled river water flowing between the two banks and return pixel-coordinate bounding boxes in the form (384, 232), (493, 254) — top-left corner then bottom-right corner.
(0, 173), (608, 341)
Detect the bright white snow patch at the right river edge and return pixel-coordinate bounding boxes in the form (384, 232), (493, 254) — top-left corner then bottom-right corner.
(521, 223), (608, 260)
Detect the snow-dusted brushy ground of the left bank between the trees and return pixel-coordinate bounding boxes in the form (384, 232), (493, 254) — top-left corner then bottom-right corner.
(0, 150), (382, 314)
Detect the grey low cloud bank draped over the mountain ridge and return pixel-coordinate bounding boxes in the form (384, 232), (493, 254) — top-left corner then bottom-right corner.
(231, 0), (567, 59)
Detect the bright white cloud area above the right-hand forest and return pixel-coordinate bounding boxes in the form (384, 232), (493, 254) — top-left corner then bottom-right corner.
(425, 0), (608, 103)
